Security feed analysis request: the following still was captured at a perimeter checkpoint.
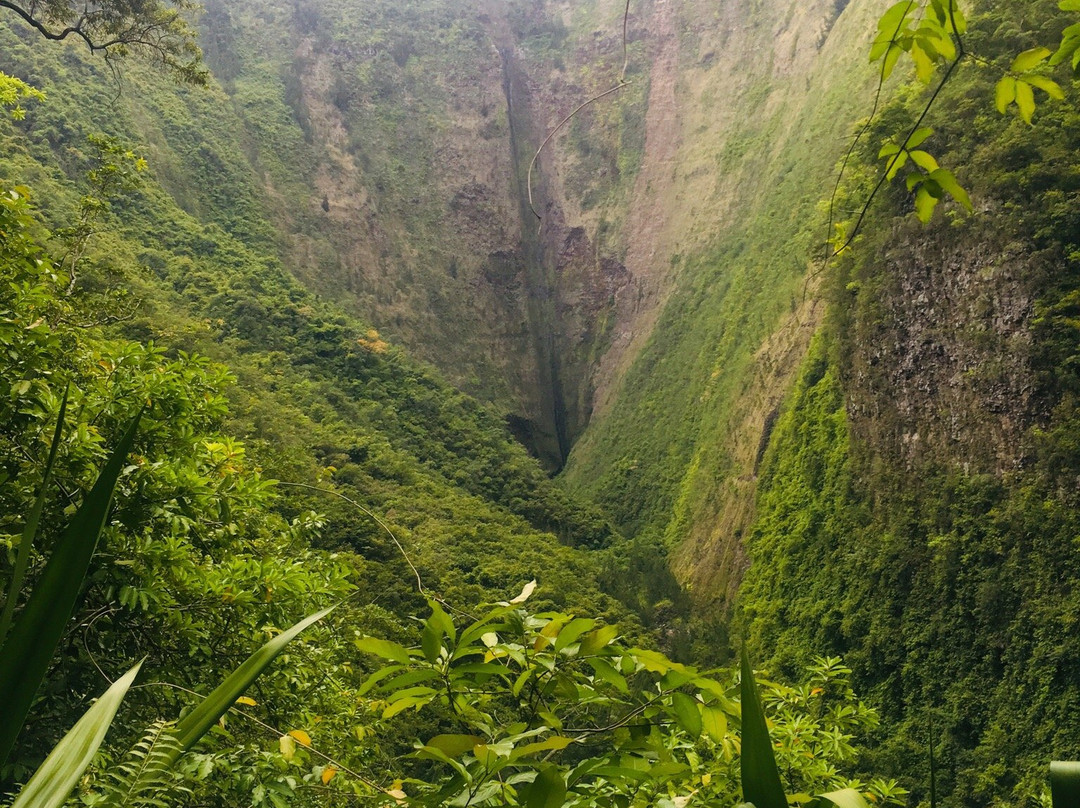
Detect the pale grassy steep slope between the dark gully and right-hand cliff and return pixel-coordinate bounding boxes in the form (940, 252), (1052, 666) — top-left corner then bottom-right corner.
(565, 3), (869, 604)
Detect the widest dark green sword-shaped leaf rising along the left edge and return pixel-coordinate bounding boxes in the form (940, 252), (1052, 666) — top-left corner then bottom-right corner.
(0, 412), (143, 765)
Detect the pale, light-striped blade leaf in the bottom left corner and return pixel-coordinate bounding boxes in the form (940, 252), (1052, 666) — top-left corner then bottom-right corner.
(11, 662), (143, 808)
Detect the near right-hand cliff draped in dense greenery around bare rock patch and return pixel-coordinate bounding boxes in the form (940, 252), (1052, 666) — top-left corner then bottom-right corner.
(740, 2), (1080, 806)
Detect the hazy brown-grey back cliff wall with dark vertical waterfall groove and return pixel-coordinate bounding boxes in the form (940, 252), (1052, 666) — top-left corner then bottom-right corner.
(194, 0), (648, 470)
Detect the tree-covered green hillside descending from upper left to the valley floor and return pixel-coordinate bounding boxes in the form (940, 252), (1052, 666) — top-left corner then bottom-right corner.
(0, 9), (656, 786)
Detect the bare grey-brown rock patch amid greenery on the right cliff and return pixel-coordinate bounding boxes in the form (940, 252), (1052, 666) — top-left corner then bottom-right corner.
(846, 218), (1052, 474)
